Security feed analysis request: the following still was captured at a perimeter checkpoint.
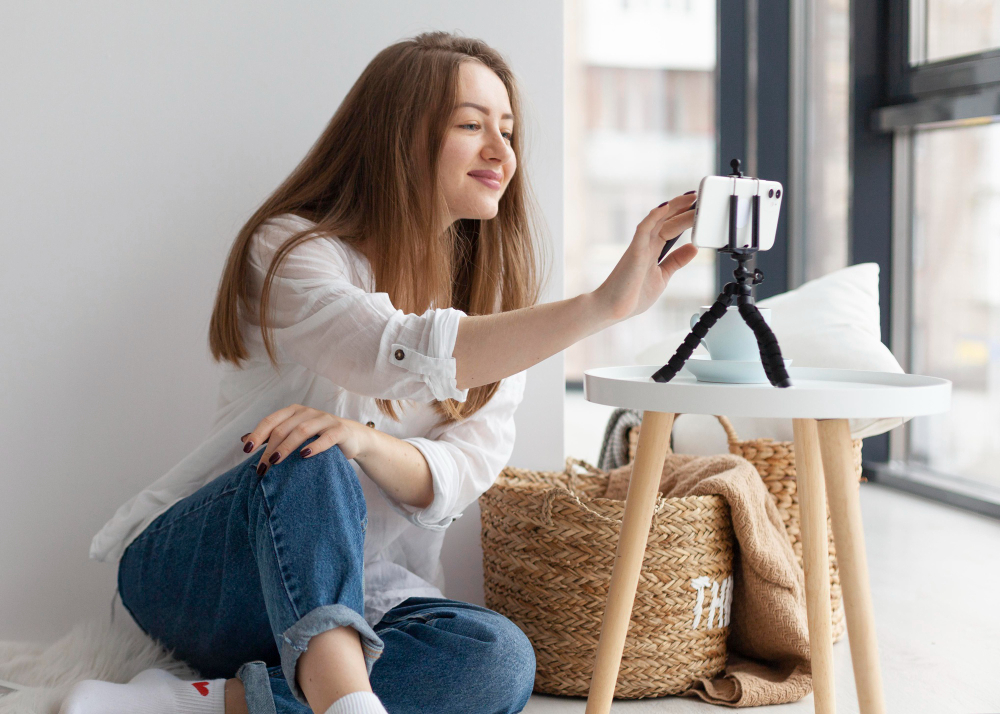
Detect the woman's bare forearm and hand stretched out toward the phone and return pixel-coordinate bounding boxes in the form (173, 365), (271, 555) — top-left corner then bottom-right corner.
(453, 195), (698, 389)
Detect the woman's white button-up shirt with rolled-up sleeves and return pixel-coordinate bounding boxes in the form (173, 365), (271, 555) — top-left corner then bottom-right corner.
(90, 214), (526, 626)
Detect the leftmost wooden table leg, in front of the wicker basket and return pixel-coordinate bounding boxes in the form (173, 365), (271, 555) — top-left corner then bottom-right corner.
(586, 412), (674, 714)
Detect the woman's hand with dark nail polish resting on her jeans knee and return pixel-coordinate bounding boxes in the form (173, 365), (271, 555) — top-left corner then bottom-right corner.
(242, 404), (368, 474)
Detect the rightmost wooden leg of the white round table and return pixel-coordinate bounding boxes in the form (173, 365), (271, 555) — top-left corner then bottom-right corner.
(816, 419), (885, 714)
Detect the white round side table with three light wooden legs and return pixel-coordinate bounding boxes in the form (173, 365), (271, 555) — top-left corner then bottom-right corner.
(583, 365), (951, 714)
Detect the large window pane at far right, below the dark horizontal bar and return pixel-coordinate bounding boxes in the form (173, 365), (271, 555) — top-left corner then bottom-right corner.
(909, 124), (1000, 486)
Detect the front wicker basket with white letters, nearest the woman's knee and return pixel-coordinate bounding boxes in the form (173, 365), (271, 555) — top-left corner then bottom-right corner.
(479, 458), (734, 699)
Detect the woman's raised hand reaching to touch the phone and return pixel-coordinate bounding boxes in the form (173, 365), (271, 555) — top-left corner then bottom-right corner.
(593, 191), (698, 321)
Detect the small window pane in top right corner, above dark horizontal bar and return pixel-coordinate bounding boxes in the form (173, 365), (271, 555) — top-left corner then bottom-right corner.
(910, 0), (1000, 62)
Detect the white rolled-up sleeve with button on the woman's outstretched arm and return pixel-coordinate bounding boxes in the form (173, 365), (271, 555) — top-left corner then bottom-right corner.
(245, 214), (469, 402)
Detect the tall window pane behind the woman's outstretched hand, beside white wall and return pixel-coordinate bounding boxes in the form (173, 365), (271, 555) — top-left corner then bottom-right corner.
(565, 0), (716, 382)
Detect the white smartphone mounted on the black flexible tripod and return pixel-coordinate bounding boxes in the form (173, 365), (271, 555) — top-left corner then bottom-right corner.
(691, 176), (784, 250)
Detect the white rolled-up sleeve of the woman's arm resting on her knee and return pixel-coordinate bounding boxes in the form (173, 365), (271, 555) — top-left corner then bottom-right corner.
(380, 372), (526, 530)
